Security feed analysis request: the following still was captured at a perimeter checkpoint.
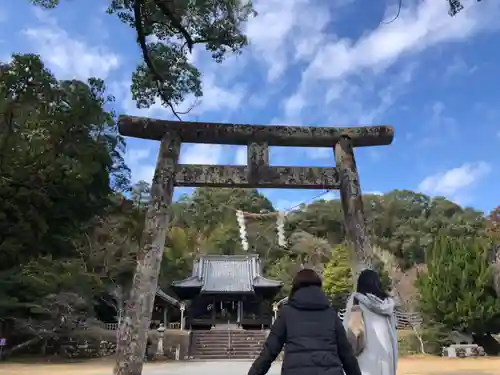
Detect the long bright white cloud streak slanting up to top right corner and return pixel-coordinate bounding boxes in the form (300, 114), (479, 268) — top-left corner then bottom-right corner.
(304, 0), (499, 83)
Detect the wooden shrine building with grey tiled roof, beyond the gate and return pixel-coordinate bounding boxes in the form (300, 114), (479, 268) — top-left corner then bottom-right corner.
(172, 254), (282, 330)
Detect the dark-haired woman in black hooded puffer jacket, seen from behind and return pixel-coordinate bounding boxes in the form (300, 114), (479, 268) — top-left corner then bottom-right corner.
(248, 269), (361, 375)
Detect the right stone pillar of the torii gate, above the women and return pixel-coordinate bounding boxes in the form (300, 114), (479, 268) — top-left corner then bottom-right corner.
(334, 136), (372, 280)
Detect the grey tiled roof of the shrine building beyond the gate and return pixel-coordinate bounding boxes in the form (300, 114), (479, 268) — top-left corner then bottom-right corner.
(172, 254), (282, 293)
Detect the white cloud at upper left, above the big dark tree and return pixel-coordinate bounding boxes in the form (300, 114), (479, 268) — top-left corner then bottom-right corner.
(22, 8), (120, 80)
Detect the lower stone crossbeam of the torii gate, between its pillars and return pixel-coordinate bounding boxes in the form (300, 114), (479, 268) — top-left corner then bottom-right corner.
(175, 164), (340, 189)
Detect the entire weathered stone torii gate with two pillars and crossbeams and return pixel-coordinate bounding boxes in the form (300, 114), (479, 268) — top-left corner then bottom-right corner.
(115, 116), (394, 375)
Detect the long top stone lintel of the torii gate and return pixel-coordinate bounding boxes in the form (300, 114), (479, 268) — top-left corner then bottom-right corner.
(118, 116), (394, 147)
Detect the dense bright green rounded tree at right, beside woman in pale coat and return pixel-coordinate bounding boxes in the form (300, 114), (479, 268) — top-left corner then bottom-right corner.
(417, 236), (500, 334)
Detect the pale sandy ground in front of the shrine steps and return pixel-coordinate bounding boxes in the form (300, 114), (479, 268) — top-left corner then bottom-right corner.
(0, 357), (500, 375)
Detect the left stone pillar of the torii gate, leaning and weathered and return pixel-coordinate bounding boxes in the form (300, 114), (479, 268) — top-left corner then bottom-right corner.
(114, 133), (181, 375)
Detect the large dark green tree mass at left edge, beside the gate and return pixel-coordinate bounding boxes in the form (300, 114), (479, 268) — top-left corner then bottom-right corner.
(0, 55), (133, 344)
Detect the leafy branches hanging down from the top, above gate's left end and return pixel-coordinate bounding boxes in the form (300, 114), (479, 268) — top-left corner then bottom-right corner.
(31, 0), (256, 118)
